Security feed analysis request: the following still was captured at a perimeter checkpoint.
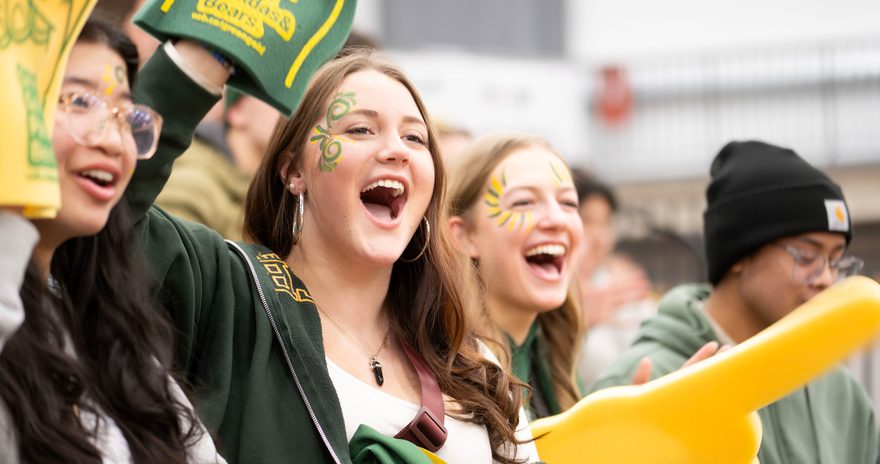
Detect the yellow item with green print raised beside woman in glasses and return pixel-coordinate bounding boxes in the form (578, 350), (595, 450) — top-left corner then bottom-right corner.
(0, 0), (97, 217)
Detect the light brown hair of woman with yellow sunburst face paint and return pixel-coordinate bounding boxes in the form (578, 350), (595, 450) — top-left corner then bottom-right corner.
(447, 133), (583, 411)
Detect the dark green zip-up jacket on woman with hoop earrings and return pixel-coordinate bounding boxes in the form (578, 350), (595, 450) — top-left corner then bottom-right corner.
(126, 44), (427, 463)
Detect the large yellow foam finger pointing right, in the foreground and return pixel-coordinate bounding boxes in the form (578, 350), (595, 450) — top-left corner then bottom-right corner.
(531, 276), (880, 464)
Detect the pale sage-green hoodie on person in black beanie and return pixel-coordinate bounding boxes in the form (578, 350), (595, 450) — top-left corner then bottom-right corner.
(590, 285), (880, 464)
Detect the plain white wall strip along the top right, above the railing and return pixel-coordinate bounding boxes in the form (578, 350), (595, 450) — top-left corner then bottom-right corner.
(567, 0), (880, 63)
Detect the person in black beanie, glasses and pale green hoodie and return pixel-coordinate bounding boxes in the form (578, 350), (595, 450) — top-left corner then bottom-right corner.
(590, 141), (880, 464)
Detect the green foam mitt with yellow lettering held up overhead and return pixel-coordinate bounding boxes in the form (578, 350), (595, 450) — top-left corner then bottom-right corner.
(134, 0), (357, 115)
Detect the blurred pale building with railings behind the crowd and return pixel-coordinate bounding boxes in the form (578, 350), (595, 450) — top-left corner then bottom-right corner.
(355, 0), (880, 414)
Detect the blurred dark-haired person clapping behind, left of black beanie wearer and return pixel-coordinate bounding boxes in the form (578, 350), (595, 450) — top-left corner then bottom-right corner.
(572, 169), (656, 383)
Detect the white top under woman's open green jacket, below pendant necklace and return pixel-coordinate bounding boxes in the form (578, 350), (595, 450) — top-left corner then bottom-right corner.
(327, 344), (540, 463)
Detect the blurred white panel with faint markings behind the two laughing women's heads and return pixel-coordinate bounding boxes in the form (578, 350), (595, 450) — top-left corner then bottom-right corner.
(391, 51), (588, 159)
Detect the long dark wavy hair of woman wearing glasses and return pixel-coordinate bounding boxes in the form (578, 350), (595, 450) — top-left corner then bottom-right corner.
(0, 20), (198, 463)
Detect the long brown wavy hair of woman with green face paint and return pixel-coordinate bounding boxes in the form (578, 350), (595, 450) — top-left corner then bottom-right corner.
(244, 49), (521, 462)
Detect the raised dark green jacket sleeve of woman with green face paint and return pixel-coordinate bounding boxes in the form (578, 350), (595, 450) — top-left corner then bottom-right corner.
(125, 48), (252, 404)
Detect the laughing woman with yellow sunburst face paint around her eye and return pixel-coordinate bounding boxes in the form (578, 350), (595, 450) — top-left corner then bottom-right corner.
(448, 134), (583, 419)
